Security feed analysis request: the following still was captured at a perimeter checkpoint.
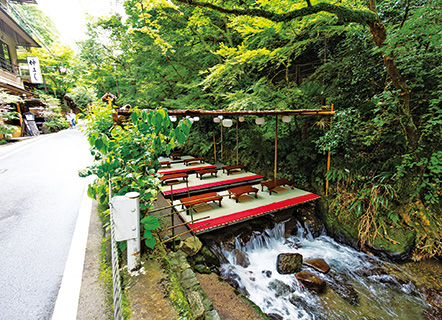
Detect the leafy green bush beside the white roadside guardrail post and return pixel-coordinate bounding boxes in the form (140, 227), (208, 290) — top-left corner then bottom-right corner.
(83, 104), (190, 248)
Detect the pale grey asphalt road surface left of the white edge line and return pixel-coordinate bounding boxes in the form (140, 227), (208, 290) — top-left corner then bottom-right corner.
(0, 130), (92, 320)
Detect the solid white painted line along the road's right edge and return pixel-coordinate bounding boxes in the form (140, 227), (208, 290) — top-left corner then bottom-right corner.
(51, 186), (92, 320)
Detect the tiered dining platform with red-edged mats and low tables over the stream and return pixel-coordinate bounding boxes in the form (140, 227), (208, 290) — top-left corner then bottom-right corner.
(159, 156), (319, 234)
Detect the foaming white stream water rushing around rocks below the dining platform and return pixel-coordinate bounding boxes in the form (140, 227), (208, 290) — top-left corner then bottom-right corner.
(221, 224), (424, 320)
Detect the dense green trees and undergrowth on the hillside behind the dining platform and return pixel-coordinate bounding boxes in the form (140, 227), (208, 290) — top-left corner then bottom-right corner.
(74, 0), (442, 259)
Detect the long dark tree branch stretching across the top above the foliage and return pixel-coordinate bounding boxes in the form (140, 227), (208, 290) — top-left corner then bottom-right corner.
(176, 0), (377, 25)
